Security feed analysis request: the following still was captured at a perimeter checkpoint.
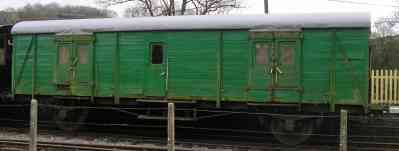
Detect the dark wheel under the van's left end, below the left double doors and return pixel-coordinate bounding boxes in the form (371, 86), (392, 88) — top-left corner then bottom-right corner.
(54, 108), (89, 131)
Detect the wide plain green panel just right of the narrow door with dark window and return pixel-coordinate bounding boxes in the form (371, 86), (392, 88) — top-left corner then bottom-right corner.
(166, 32), (220, 100)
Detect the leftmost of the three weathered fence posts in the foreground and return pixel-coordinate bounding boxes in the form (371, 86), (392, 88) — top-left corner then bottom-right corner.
(29, 99), (37, 151)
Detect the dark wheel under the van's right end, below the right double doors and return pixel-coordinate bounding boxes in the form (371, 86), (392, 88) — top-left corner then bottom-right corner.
(270, 118), (315, 145)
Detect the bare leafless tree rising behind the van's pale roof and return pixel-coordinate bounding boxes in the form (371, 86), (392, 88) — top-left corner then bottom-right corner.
(96, 0), (241, 17)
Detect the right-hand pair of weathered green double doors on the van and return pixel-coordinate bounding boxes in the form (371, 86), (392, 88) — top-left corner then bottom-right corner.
(249, 31), (302, 103)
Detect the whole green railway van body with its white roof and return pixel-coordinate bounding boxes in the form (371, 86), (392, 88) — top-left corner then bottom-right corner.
(12, 13), (370, 109)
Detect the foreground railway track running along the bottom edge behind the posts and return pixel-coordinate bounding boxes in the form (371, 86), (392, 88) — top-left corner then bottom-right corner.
(0, 140), (337, 151)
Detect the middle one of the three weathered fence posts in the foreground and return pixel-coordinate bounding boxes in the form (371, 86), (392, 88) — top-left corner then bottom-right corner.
(168, 103), (175, 151)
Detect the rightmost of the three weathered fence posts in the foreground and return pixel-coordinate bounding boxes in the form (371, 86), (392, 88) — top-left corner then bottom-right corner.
(339, 110), (348, 151)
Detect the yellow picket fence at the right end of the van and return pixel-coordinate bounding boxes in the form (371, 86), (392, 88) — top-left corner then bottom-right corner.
(371, 69), (399, 105)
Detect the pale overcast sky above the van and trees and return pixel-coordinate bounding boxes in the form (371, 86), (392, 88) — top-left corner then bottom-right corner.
(0, 0), (399, 21)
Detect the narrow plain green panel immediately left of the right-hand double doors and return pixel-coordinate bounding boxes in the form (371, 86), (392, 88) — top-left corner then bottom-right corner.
(221, 31), (252, 101)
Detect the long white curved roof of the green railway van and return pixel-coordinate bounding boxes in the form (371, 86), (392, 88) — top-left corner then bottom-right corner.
(11, 13), (370, 34)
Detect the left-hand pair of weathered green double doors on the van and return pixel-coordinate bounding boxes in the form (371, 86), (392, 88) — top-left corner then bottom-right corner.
(54, 35), (93, 96)
